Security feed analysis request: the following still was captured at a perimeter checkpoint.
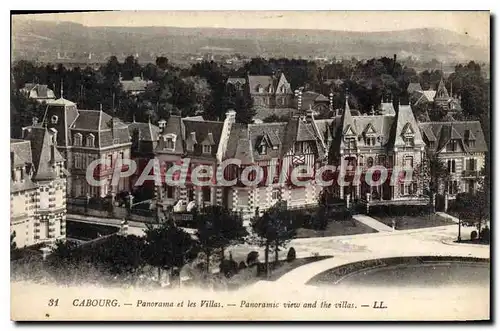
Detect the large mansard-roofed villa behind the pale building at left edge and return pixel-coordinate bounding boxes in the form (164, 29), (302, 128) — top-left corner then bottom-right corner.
(23, 98), (132, 198)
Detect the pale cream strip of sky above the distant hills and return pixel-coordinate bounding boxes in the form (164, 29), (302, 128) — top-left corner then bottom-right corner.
(14, 11), (490, 44)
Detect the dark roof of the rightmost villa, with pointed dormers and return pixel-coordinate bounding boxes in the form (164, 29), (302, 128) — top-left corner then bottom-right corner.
(419, 121), (488, 153)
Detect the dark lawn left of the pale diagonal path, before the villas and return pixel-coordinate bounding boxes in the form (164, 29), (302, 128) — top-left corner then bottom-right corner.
(297, 218), (377, 238)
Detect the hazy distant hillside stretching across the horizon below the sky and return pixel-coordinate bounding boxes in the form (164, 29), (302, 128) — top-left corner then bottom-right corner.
(12, 20), (489, 62)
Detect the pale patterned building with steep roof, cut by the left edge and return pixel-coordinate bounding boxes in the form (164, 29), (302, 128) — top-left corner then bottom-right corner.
(10, 127), (67, 248)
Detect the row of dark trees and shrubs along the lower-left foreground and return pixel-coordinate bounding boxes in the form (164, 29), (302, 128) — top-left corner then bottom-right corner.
(11, 202), (298, 285)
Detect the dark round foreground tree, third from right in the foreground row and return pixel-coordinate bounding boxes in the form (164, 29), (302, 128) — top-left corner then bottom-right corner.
(144, 221), (199, 281)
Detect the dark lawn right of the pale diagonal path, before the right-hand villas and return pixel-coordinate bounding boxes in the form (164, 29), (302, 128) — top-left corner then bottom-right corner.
(370, 213), (455, 230)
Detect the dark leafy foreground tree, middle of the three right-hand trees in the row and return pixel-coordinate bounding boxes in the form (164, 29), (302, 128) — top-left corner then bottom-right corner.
(194, 206), (248, 273)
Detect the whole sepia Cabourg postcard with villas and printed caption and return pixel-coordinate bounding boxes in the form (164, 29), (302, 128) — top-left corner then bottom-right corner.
(10, 11), (493, 321)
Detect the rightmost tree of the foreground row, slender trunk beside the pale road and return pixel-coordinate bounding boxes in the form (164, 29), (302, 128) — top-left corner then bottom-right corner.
(252, 201), (297, 277)
